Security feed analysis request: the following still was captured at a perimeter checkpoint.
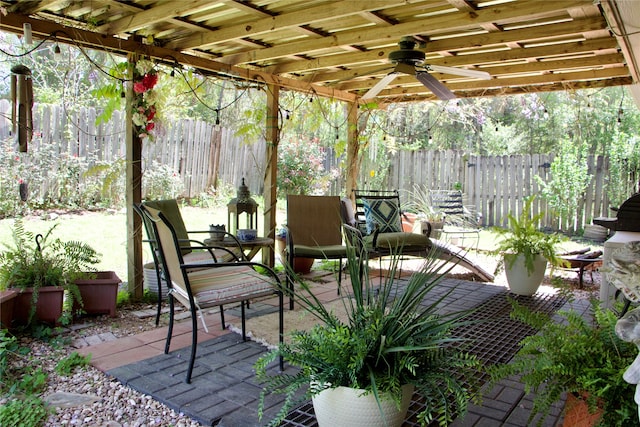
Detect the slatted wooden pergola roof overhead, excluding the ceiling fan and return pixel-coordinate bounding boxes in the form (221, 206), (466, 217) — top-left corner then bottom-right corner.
(0, 0), (640, 103)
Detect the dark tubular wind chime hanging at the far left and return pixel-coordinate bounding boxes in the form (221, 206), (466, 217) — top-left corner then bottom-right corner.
(11, 65), (33, 153)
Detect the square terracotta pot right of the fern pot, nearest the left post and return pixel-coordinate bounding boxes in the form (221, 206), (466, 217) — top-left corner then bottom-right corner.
(73, 271), (122, 317)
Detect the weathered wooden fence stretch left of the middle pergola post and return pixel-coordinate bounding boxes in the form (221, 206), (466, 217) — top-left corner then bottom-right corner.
(0, 100), (265, 197)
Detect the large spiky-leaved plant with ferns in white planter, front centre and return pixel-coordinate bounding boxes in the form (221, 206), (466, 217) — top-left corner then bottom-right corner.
(255, 242), (479, 427)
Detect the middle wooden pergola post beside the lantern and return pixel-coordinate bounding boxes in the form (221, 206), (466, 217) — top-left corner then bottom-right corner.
(262, 84), (280, 267)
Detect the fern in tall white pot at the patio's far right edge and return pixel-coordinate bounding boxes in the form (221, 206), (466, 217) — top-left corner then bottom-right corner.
(493, 196), (564, 295)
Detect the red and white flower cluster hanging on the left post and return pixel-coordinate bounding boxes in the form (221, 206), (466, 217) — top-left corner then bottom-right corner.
(132, 59), (158, 139)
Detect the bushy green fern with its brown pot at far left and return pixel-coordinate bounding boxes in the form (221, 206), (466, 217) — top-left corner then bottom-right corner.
(0, 219), (99, 325)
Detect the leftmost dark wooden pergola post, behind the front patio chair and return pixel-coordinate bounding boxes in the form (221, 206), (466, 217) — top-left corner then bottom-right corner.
(125, 54), (144, 300)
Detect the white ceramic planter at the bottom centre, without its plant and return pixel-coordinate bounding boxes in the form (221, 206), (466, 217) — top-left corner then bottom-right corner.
(313, 384), (413, 427)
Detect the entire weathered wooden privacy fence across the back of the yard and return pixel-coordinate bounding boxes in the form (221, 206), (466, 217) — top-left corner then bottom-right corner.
(0, 100), (638, 229)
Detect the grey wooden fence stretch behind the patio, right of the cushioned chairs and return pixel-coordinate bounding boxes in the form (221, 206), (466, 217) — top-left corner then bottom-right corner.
(388, 151), (637, 229)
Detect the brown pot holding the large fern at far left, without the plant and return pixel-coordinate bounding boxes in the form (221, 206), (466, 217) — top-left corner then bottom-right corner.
(13, 286), (64, 325)
